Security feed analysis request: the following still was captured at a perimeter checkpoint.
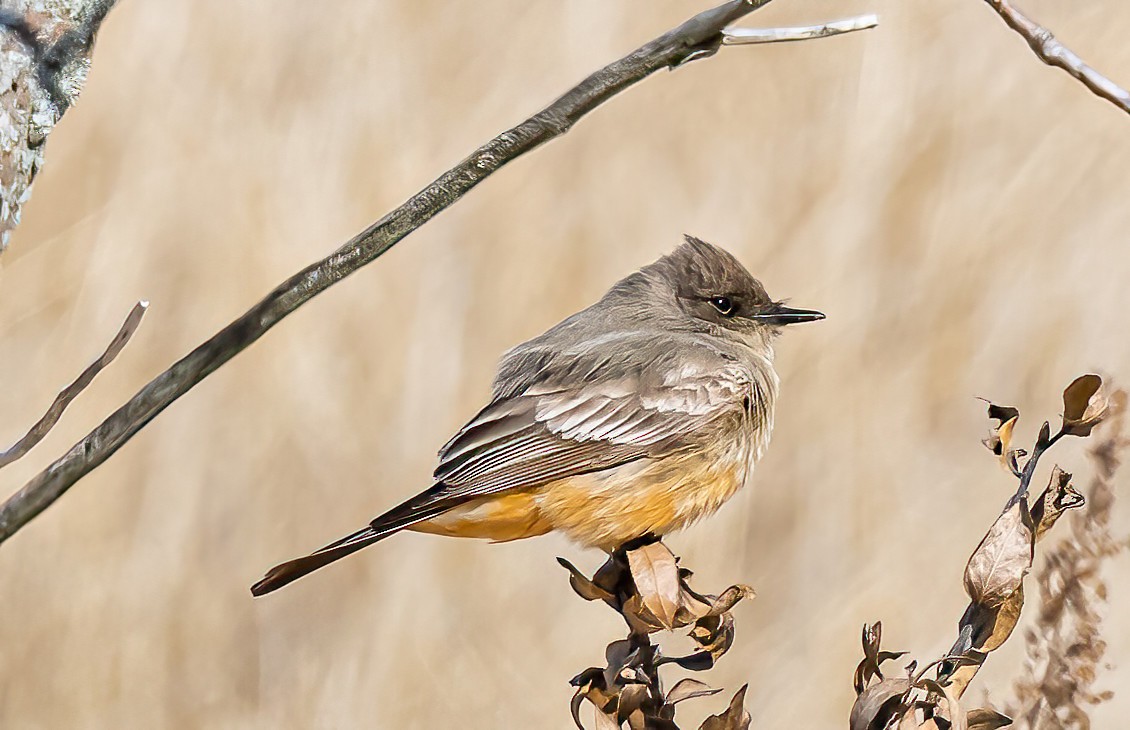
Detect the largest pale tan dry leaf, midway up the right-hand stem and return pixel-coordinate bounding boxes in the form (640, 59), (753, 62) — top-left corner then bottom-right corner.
(965, 498), (1035, 608)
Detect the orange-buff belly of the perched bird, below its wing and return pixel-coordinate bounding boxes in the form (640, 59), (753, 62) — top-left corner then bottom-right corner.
(411, 452), (748, 551)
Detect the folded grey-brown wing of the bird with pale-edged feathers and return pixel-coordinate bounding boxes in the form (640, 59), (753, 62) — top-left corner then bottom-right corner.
(434, 353), (751, 501)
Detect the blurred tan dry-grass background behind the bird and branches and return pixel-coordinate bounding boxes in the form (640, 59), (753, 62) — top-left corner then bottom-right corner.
(0, 0), (1130, 729)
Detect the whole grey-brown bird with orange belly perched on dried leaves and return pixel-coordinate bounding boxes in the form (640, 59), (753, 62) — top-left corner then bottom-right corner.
(251, 236), (824, 596)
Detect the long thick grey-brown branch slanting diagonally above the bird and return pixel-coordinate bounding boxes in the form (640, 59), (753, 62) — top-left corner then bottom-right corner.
(0, 0), (872, 542)
